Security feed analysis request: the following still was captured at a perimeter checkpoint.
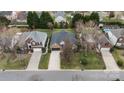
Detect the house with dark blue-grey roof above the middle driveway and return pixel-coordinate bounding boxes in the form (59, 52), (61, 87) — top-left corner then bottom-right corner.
(50, 30), (76, 50)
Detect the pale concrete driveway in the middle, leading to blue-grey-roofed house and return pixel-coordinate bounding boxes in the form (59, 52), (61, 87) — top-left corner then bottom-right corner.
(48, 51), (60, 70)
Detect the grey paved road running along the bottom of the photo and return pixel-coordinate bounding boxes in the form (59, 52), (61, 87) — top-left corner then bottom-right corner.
(0, 70), (124, 81)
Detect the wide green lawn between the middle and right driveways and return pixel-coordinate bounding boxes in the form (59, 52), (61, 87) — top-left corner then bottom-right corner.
(61, 53), (105, 69)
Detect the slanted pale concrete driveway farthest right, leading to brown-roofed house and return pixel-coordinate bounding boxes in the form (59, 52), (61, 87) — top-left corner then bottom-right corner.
(101, 48), (120, 70)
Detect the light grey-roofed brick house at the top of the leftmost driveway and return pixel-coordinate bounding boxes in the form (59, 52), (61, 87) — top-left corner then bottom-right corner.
(15, 31), (47, 50)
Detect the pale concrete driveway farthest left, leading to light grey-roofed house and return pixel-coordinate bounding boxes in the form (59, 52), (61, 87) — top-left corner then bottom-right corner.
(26, 49), (42, 70)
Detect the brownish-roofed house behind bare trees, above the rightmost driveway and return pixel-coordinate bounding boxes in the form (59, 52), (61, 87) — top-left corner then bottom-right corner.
(81, 33), (112, 50)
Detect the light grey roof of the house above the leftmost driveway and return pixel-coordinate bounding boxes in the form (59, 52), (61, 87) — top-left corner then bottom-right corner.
(19, 31), (47, 47)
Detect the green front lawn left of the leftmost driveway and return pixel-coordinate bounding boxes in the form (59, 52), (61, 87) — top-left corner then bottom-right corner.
(0, 54), (30, 69)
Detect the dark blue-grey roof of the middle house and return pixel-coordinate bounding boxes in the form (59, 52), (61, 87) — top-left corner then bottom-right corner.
(51, 30), (76, 46)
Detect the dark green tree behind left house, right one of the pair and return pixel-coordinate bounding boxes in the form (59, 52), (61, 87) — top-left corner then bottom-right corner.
(40, 12), (54, 29)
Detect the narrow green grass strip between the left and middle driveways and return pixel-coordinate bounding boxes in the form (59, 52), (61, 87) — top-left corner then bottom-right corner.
(39, 53), (50, 69)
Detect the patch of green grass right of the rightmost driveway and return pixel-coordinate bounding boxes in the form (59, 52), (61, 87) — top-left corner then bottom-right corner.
(112, 48), (124, 69)
